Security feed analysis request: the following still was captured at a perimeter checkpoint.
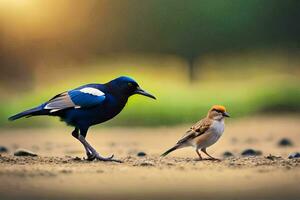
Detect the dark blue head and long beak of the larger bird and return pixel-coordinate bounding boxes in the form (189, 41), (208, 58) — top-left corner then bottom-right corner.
(108, 76), (156, 99)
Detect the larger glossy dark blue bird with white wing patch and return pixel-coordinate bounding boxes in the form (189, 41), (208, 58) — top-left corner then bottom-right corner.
(9, 76), (156, 162)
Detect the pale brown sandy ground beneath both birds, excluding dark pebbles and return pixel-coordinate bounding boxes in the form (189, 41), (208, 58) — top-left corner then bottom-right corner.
(0, 116), (300, 200)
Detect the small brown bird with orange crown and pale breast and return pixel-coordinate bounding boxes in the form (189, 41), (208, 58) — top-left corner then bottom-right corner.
(161, 105), (230, 160)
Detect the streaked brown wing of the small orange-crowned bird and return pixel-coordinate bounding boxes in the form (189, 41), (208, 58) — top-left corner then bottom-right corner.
(177, 118), (212, 145)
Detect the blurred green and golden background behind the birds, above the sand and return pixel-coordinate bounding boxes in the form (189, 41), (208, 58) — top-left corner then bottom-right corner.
(0, 0), (300, 127)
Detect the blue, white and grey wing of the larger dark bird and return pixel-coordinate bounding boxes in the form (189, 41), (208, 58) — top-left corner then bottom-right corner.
(44, 87), (105, 112)
